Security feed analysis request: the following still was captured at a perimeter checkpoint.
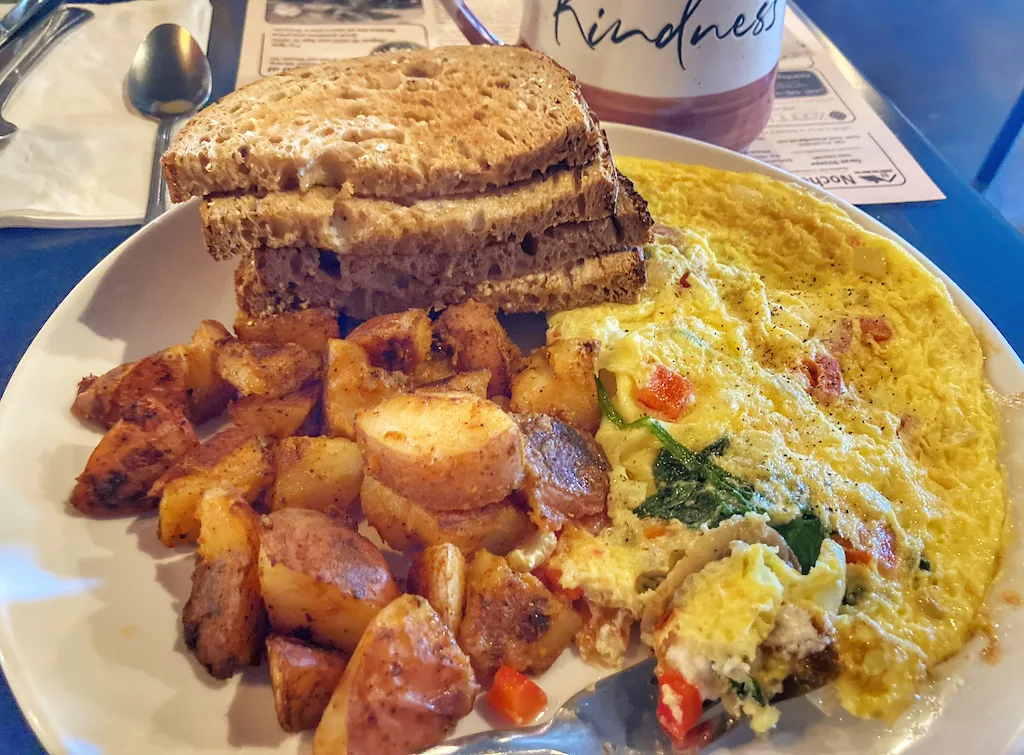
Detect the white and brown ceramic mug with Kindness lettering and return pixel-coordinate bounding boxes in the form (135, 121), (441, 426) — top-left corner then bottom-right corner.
(441, 0), (785, 150)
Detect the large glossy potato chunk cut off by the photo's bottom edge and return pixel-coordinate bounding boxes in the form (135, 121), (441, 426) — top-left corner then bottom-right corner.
(313, 595), (480, 755)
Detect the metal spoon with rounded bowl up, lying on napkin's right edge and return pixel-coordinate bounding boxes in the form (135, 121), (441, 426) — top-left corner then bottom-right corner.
(128, 24), (213, 223)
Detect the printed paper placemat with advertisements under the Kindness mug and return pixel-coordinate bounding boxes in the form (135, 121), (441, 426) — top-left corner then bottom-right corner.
(238, 0), (944, 205)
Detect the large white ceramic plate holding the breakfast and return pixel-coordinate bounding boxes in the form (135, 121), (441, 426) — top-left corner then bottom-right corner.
(0, 125), (1024, 755)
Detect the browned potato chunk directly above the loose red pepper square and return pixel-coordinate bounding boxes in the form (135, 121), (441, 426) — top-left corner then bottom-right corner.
(459, 550), (583, 681)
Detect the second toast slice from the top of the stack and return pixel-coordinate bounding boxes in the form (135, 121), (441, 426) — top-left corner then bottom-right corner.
(202, 150), (617, 259)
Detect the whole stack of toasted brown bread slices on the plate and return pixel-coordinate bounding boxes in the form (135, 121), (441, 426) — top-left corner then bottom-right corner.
(163, 47), (651, 319)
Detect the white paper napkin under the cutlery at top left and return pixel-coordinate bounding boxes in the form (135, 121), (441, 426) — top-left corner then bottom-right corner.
(0, 0), (212, 227)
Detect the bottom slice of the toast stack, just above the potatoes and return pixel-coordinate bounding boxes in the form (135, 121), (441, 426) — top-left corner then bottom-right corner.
(234, 247), (647, 320)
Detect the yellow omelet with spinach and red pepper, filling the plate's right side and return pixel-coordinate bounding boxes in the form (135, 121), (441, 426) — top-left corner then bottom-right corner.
(548, 158), (1007, 728)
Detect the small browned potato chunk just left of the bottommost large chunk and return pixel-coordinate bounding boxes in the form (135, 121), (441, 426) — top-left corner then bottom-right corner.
(266, 634), (348, 732)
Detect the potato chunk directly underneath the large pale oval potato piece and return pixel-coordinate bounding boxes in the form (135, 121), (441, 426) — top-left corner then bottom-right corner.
(359, 474), (534, 554)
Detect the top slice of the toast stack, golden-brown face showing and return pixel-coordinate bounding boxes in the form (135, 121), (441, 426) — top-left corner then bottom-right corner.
(163, 46), (601, 202)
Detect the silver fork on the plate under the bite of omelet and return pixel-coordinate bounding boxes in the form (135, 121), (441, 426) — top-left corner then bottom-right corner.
(421, 659), (745, 755)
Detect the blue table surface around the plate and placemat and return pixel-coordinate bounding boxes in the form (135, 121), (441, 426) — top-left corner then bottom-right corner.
(0, 0), (1024, 753)
